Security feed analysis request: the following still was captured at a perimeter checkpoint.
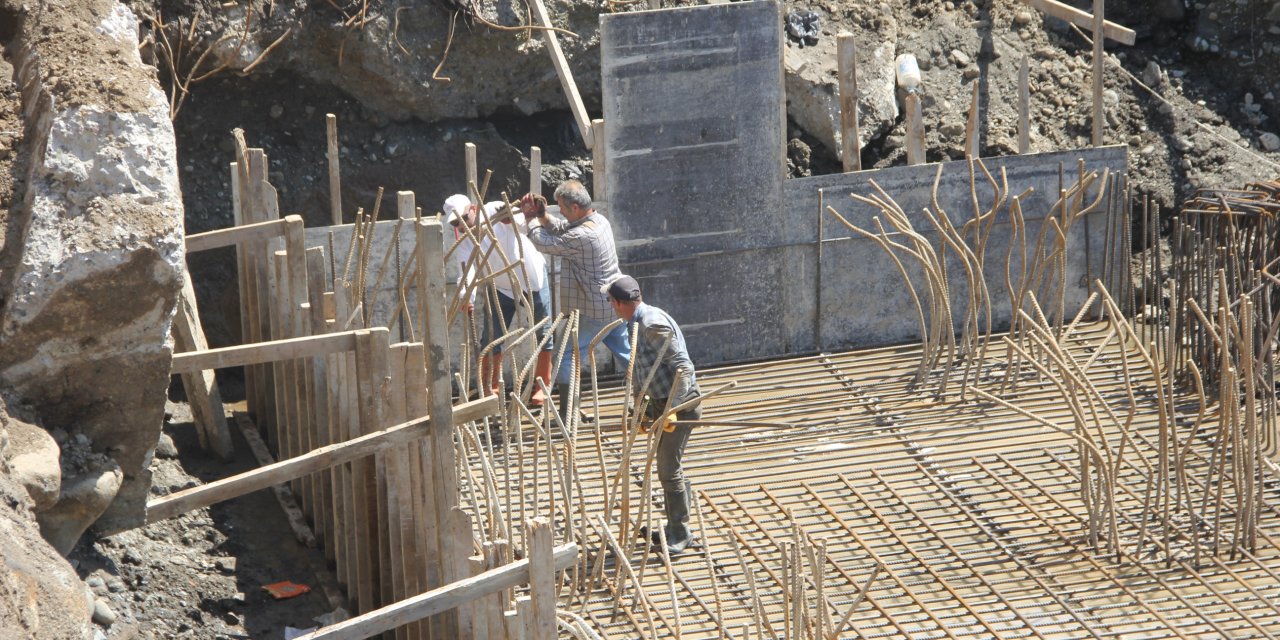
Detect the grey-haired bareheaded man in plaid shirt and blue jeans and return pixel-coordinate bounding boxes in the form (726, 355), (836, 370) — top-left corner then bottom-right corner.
(520, 180), (631, 422)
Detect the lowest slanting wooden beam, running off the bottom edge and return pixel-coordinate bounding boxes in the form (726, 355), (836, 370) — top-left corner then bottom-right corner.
(297, 543), (577, 640)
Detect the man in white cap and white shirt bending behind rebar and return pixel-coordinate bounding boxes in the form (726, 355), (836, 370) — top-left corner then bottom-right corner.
(444, 193), (553, 407)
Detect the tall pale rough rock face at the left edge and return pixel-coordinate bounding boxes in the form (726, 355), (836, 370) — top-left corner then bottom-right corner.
(0, 0), (184, 530)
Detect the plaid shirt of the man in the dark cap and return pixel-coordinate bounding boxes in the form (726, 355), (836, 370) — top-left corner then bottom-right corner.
(631, 302), (700, 411)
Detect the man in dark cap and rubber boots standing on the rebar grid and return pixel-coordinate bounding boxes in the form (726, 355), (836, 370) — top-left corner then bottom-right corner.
(602, 275), (703, 553)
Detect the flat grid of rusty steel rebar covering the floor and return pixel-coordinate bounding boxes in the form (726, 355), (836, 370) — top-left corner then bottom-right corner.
(463, 323), (1280, 639)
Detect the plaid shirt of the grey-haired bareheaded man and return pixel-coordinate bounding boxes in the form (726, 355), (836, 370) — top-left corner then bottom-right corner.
(529, 211), (621, 323)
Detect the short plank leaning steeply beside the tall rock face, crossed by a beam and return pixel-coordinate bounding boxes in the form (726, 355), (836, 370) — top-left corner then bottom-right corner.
(173, 269), (236, 460)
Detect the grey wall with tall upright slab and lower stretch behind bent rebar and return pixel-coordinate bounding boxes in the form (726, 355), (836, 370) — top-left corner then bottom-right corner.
(598, 1), (1126, 365)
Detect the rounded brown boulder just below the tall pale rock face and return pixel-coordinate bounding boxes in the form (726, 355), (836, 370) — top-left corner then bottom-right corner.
(38, 458), (124, 556)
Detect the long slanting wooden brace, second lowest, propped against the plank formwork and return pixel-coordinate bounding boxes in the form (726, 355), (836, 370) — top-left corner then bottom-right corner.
(147, 396), (498, 524)
